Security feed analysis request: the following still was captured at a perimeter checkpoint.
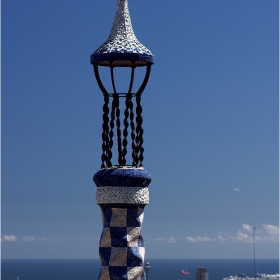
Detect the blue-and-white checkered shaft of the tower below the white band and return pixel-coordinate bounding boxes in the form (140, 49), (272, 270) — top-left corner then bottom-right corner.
(99, 205), (146, 280)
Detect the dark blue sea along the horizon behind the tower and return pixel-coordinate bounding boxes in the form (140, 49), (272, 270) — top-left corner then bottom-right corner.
(1, 259), (279, 280)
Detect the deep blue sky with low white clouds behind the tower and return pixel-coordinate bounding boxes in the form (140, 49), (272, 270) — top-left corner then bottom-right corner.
(1, 0), (279, 258)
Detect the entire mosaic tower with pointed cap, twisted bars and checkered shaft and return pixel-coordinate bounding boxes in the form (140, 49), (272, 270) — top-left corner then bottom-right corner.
(90, 0), (154, 280)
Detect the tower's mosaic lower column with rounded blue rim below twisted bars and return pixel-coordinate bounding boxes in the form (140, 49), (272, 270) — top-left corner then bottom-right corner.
(93, 166), (152, 280)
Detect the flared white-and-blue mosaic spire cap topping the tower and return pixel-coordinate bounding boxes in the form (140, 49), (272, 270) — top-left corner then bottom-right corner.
(90, 0), (154, 66)
